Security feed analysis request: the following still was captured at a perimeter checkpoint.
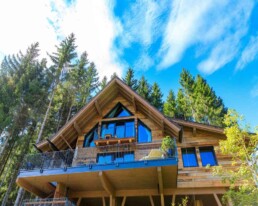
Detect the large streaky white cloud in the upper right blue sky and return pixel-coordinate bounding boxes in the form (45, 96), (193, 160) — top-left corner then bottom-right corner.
(159, 0), (253, 74)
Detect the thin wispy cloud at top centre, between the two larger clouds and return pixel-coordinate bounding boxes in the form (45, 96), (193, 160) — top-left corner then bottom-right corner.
(121, 0), (168, 47)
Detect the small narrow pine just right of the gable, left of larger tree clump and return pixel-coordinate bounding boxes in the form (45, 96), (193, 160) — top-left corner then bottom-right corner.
(163, 89), (176, 117)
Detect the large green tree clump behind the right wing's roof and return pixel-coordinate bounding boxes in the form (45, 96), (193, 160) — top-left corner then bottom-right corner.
(176, 69), (227, 126)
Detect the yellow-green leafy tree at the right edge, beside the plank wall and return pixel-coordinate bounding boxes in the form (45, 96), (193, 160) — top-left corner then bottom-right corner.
(213, 110), (258, 206)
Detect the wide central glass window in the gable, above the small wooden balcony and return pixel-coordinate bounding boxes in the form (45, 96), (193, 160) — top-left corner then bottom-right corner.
(101, 120), (135, 138)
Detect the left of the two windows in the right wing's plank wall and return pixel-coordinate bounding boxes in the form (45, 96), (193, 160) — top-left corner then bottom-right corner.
(181, 148), (198, 167)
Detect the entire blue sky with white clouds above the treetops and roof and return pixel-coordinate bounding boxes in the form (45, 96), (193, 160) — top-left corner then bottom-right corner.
(0, 0), (258, 129)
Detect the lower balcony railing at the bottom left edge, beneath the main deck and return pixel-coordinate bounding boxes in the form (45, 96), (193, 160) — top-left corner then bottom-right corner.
(22, 198), (75, 206)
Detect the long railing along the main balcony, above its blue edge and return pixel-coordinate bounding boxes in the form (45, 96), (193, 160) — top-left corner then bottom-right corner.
(21, 141), (177, 171)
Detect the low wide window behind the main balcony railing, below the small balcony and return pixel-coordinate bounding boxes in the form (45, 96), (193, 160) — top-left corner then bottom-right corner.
(97, 152), (134, 164)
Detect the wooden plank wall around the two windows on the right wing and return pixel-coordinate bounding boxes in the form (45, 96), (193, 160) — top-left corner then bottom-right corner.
(177, 127), (234, 188)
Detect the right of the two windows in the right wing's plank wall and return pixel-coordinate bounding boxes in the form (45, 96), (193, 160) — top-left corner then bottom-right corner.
(199, 147), (217, 167)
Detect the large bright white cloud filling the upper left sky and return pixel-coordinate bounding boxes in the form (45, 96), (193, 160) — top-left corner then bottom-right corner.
(0, 0), (122, 77)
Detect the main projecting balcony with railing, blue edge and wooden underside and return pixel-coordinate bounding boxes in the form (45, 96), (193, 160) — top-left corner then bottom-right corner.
(17, 142), (178, 198)
